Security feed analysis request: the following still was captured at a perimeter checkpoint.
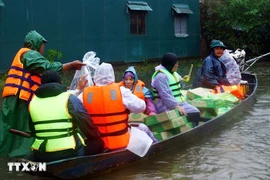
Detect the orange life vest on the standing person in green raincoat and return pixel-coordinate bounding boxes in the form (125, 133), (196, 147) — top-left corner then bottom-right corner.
(2, 48), (41, 102)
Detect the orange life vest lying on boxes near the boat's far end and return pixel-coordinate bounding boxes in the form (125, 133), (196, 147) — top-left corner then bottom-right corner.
(212, 85), (247, 99)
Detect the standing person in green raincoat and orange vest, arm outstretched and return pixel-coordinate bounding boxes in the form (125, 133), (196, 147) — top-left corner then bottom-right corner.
(0, 30), (85, 157)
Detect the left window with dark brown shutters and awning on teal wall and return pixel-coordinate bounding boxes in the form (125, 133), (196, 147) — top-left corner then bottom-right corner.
(127, 1), (153, 35)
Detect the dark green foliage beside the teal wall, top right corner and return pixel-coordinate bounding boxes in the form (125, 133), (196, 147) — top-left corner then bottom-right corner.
(201, 0), (270, 55)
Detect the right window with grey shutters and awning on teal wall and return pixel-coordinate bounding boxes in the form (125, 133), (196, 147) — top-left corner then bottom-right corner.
(172, 4), (193, 37)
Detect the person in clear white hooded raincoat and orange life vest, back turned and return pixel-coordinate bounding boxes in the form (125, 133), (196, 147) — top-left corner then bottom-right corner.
(79, 63), (146, 150)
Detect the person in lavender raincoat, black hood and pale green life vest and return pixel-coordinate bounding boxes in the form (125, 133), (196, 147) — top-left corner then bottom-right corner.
(151, 53), (200, 126)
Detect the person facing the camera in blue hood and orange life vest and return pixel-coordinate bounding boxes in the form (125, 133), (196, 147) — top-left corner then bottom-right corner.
(120, 66), (157, 116)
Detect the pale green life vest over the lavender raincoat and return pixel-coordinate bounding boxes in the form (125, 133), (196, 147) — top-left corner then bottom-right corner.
(152, 68), (184, 102)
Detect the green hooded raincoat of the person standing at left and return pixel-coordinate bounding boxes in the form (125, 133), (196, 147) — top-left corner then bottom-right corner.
(0, 31), (62, 156)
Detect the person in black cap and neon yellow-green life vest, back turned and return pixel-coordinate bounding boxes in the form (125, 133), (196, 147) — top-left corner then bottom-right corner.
(29, 71), (104, 162)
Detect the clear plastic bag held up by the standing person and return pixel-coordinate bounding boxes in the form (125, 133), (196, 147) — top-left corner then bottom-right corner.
(69, 51), (100, 90)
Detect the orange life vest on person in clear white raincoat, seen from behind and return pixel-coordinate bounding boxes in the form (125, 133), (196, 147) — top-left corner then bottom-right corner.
(83, 83), (130, 150)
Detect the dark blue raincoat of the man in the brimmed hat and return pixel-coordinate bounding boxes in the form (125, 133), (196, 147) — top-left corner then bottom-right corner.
(193, 51), (230, 89)
